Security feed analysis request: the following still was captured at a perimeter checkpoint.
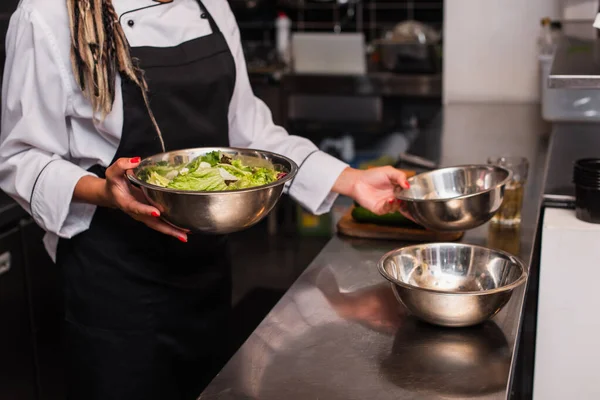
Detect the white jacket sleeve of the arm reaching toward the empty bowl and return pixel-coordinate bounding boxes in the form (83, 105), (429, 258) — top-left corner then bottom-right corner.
(223, 2), (348, 214)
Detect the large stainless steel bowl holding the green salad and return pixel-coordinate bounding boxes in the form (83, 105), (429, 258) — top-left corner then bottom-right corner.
(127, 147), (298, 234)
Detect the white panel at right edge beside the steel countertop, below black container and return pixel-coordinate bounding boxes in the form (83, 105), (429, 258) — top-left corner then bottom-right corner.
(533, 208), (600, 400)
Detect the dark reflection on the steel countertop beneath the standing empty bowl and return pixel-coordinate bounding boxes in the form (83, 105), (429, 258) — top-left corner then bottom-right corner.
(381, 317), (512, 399)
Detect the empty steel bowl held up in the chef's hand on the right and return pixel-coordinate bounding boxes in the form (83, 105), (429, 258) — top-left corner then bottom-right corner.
(396, 165), (512, 231)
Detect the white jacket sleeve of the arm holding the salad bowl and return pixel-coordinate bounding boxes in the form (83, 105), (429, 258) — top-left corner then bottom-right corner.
(0, 7), (95, 238)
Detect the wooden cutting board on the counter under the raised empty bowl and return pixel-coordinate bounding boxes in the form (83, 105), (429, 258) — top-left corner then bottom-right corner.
(337, 209), (465, 242)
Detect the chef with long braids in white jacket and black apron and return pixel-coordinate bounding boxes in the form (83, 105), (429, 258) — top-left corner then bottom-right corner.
(0, 0), (407, 400)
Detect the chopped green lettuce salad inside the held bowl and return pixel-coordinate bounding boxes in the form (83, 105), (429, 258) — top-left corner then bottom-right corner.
(138, 151), (286, 192)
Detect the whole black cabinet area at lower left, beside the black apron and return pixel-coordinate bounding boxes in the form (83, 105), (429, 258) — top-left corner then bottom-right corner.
(0, 212), (65, 400)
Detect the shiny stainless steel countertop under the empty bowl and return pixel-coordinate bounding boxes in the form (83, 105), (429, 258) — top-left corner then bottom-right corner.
(200, 105), (547, 400)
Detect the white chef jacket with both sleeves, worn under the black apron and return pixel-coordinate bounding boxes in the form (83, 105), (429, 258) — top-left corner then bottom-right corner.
(0, 0), (347, 258)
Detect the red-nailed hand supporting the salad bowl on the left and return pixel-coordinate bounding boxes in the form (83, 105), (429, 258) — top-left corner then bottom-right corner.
(73, 157), (187, 242)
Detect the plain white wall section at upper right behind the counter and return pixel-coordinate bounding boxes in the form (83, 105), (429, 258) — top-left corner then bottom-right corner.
(444, 0), (564, 103)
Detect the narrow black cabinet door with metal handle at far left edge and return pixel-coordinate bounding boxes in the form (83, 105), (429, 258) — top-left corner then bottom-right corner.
(0, 227), (36, 400)
